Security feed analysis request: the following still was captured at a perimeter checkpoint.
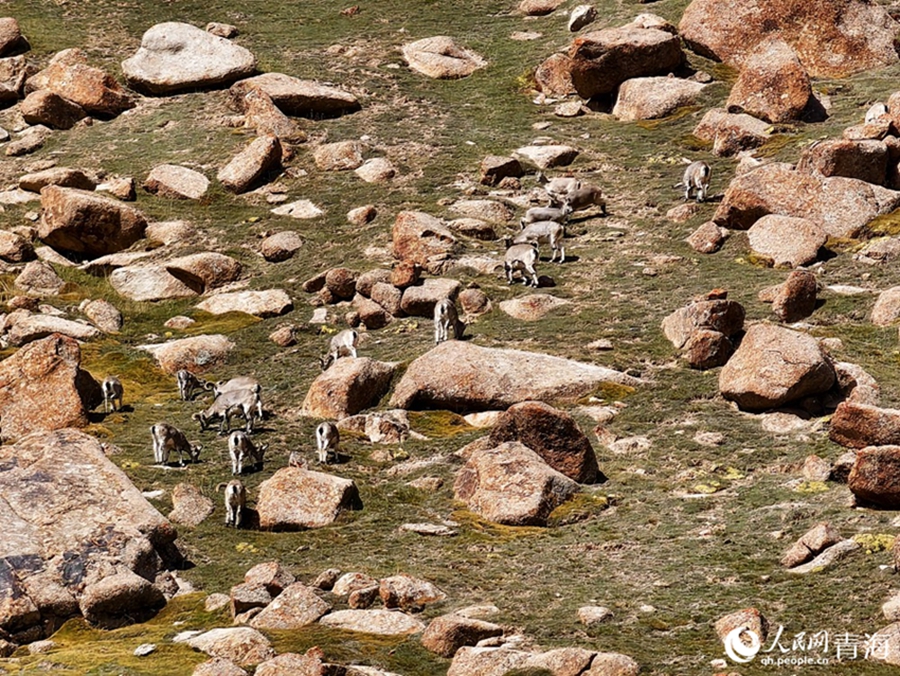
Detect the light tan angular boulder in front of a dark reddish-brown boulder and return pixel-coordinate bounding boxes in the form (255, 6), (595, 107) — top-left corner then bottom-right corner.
(453, 441), (579, 526)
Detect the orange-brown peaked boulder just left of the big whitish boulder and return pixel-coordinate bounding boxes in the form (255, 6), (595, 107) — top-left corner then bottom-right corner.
(25, 49), (134, 115)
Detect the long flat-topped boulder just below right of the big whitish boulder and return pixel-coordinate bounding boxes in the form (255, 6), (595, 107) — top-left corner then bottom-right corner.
(228, 73), (360, 117)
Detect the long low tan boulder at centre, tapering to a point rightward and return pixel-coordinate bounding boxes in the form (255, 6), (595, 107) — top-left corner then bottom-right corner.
(390, 340), (641, 411)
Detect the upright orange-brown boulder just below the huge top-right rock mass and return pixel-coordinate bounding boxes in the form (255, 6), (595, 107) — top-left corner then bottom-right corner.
(726, 39), (812, 122)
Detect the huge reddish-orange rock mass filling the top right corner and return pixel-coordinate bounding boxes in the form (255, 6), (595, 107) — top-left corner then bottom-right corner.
(678, 0), (898, 77)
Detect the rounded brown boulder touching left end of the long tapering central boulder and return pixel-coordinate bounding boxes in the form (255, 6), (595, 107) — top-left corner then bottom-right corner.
(302, 357), (397, 420)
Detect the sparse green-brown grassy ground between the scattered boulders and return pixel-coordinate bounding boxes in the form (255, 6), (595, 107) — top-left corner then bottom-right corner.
(0, 0), (900, 676)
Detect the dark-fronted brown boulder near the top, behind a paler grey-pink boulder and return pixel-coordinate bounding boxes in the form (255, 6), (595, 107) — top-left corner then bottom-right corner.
(568, 25), (684, 99)
